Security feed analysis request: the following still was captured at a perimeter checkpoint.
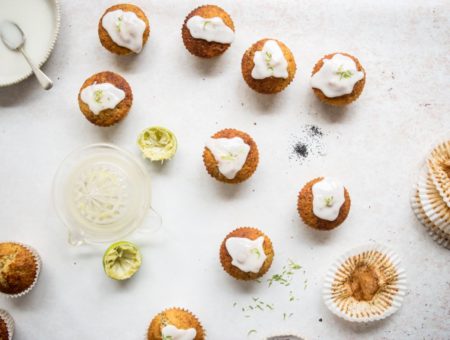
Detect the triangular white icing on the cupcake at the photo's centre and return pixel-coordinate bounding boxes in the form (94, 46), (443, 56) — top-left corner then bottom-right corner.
(206, 137), (250, 179)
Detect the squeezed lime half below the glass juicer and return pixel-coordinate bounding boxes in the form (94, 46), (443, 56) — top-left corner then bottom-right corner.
(103, 241), (142, 280)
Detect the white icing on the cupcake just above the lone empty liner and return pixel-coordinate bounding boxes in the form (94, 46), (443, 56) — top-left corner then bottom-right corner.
(312, 178), (345, 221)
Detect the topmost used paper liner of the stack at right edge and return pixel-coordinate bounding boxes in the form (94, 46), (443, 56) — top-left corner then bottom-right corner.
(427, 140), (450, 207)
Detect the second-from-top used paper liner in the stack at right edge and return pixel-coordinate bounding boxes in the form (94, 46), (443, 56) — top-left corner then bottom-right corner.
(417, 173), (450, 234)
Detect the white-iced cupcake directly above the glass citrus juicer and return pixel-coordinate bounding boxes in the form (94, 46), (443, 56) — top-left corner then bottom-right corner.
(78, 71), (133, 126)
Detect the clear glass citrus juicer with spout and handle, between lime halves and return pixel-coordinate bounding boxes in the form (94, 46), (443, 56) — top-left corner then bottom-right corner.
(53, 143), (161, 245)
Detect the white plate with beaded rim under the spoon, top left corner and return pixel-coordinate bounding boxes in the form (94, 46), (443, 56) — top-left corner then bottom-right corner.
(0, 0), (60, 87)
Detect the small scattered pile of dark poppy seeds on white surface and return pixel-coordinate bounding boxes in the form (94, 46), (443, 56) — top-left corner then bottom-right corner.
(289, 125), (325, 162)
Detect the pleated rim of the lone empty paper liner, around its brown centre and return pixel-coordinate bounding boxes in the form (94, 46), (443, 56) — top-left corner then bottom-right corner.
(323, 244), (406, 322)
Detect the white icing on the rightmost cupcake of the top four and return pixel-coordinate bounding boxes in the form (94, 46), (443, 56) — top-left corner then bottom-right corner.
(311, 53), (364, 98)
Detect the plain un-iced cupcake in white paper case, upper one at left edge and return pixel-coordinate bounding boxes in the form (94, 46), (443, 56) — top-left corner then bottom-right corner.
(0, 242), (41, 297)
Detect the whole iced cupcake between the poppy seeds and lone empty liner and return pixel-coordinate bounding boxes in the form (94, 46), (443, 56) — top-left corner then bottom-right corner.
(297, 177), (351, 230)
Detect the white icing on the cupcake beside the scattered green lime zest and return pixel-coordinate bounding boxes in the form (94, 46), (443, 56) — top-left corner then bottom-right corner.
(225, 236), (267, 273)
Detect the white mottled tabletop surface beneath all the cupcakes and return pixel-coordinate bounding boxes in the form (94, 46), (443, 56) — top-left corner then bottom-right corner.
(0, 0), (450, 340)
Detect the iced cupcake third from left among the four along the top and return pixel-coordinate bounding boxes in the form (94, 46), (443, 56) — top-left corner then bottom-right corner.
(241, 39), (297, 94)
